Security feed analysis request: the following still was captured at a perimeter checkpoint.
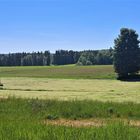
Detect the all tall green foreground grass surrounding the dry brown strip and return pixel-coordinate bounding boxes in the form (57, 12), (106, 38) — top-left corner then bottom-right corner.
(0, 98), (140, 140)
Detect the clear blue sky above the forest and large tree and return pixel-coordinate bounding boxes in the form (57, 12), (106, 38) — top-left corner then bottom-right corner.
(0, 0), (140, 53)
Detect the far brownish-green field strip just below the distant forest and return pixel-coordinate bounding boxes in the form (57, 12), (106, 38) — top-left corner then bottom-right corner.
(0, 65), (115, 79)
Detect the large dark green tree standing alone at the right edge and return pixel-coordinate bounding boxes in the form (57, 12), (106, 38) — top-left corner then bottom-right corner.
(114, 28), (140, 79)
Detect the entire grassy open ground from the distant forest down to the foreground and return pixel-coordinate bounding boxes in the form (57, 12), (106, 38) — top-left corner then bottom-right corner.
(0, 65), (140, 140)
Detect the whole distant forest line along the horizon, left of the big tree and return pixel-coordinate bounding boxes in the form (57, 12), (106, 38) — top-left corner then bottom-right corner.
(0, 49), (113, 66)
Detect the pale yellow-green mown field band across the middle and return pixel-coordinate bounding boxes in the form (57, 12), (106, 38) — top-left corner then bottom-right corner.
(0, 78), (140, 103)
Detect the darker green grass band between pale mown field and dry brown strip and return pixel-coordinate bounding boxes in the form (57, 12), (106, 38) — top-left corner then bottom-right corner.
(0, 98), (140, 121)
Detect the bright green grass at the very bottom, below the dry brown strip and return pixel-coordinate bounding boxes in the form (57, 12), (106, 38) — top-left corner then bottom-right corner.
(0, 122), (140, 140)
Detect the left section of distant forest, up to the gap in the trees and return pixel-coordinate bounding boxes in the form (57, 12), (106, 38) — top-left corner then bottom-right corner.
(0, 51), (50, 66)
